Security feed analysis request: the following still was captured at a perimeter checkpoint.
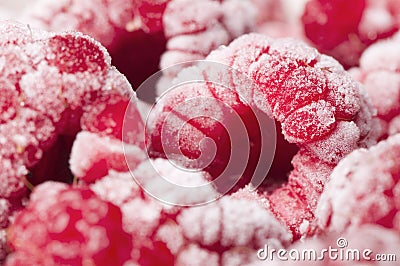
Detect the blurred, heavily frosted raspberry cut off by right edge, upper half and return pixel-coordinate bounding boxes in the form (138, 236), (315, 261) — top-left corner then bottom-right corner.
(351, 34), (400, 138)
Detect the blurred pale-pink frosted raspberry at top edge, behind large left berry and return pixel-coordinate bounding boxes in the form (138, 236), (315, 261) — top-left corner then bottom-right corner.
(22, 0), (133, 45)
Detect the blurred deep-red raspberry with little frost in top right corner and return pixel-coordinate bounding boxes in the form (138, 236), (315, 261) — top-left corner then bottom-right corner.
(302, 0), (400, 67)
